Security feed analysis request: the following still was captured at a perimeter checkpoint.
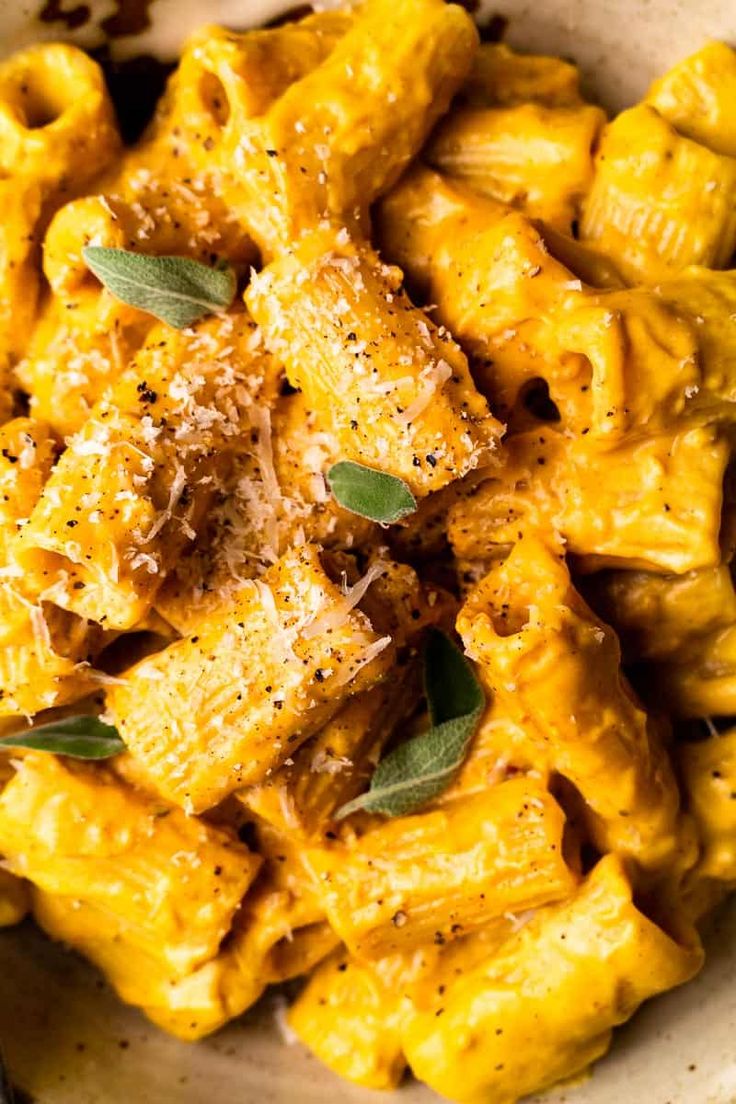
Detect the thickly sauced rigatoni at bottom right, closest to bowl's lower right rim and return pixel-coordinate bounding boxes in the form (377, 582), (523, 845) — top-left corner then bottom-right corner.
(403, 857), (701, 1104)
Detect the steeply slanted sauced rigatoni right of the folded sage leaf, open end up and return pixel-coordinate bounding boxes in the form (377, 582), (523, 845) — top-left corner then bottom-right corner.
(458, 533), (679, 867)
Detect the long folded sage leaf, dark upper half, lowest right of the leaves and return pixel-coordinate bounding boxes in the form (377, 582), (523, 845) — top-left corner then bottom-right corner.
(335, 629), (486, 820)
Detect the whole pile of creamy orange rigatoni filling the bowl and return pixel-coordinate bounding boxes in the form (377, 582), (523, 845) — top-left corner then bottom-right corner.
(0, 0), (736, 1104)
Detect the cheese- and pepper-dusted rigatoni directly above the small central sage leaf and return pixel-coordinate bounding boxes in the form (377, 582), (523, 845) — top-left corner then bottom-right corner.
(247, 237), (499, 495)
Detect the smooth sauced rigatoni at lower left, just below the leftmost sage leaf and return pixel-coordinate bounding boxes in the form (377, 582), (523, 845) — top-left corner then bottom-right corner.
(0, 755), (260, 976)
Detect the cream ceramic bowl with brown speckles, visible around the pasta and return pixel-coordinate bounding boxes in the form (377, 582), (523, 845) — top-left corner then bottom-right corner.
(0, 0), (736, 1104)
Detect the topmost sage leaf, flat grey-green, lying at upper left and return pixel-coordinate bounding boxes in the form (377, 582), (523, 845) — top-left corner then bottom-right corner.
(82, 245), (236, 330)
